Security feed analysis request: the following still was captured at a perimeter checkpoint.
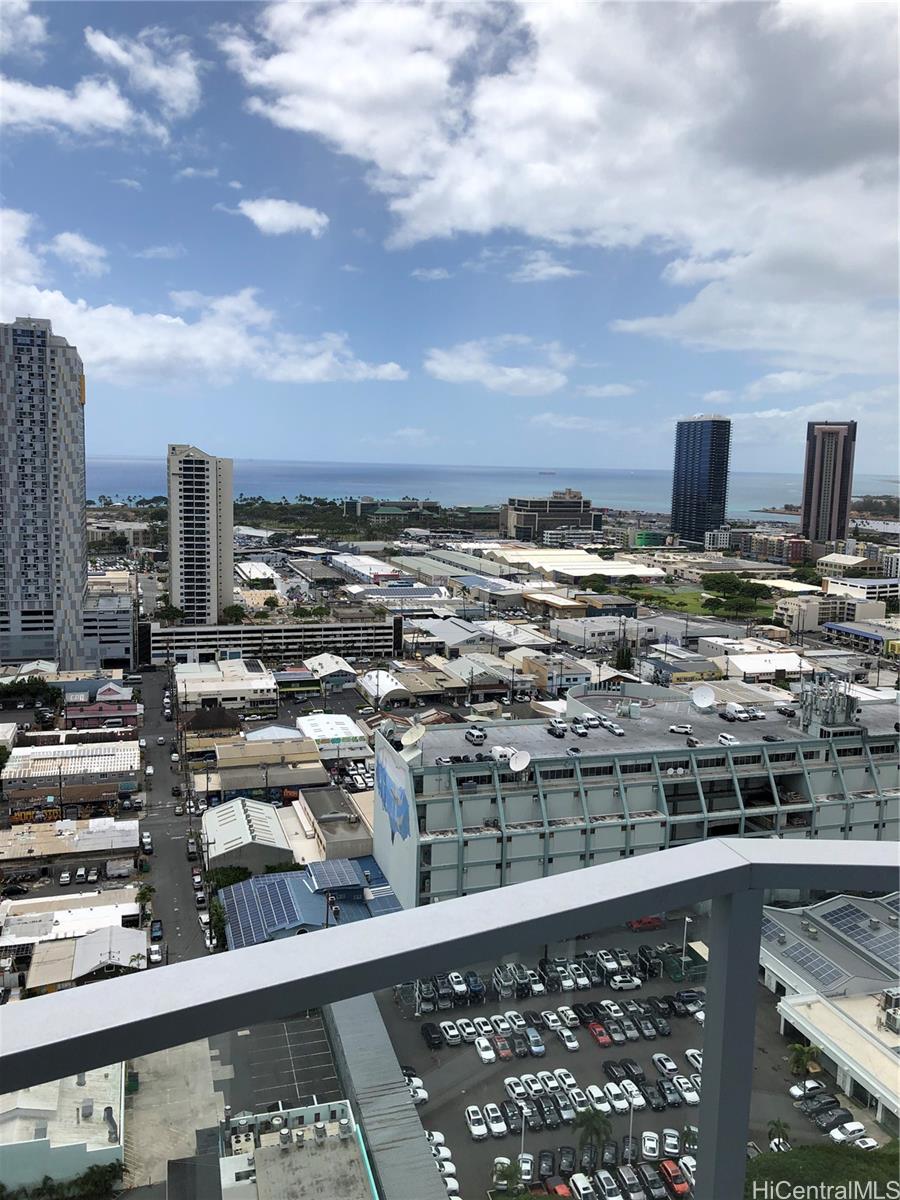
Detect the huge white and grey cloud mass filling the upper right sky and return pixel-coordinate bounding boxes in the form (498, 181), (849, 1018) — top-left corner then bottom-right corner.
(217, 0), (896, 372)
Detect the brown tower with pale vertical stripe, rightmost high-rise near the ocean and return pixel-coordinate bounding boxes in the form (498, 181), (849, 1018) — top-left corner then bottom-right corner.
(800, 421), (857, 541)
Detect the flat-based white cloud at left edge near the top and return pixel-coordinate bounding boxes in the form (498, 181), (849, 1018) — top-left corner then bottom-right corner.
(0, 78), (168, 143)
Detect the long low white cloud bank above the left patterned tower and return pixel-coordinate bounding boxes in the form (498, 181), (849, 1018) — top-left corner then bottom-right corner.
(0, 211), (407, 385)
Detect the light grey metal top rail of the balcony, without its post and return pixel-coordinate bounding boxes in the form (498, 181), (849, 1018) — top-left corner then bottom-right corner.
(0, 839), (898, 1092)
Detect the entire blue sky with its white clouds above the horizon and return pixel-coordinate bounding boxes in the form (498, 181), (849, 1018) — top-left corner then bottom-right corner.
(0, 0), (898, 475)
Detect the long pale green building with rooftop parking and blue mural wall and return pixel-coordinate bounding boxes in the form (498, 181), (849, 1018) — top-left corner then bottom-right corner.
(374, 684), (900, 907)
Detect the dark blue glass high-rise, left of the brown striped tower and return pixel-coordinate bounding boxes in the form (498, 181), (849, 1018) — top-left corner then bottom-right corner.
(672, 416), (731, 544)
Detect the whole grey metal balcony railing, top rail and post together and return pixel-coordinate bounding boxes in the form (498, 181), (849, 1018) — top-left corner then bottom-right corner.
(0, 839), (898, 1200)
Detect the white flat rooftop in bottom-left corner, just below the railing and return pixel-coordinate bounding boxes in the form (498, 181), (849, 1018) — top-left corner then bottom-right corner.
(0, 1062), (125, 1151)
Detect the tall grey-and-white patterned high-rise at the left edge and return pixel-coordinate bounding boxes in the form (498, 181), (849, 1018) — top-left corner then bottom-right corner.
(0, 317), (88, 670)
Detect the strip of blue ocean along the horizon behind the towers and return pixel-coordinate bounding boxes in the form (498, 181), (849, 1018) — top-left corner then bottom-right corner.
(88, 457), (898, 520)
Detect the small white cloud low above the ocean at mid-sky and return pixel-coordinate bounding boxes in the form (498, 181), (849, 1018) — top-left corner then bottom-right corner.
(425, 334), (572, 396)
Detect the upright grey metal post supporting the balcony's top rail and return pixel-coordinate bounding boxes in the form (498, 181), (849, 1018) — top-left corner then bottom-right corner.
(696, 890), (763, 1200)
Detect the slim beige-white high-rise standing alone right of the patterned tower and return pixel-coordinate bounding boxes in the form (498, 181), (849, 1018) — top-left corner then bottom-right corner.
(168, 445), (234, 625)
